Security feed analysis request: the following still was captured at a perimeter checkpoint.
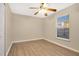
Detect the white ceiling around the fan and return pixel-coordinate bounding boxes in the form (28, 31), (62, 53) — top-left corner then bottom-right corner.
(9, 3), (73, 18)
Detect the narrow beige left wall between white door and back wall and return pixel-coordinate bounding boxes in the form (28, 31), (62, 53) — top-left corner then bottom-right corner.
(5, 4), (12, 54)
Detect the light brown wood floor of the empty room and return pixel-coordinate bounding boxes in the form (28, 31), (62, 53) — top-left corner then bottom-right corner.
(8, 40), (79, 56)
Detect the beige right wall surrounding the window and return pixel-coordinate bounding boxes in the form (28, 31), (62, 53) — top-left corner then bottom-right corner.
(44, 4), (79, 51)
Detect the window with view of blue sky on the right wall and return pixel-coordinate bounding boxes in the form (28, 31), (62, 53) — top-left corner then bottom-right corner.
(56, 14), (69, 40)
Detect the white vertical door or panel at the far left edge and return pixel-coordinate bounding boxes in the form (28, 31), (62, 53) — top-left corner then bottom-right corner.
(0, 3), (4, 56)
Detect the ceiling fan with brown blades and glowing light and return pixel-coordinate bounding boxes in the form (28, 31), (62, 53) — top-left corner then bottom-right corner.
(29, 3), (57, 16)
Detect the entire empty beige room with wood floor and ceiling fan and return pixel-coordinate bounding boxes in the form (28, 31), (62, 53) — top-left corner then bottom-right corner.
(0, 3), (79, 56)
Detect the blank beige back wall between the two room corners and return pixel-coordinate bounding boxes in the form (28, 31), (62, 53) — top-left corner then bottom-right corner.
(12, 14), (43, 41)
